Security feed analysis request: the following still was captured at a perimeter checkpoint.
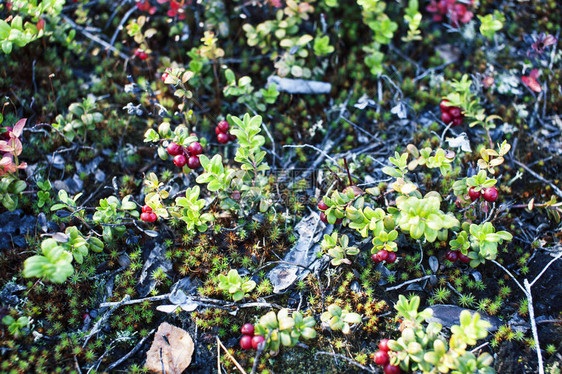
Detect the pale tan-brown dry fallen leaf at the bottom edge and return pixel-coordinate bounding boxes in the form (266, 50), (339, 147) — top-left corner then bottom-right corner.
(145, 322), (194, 374)
